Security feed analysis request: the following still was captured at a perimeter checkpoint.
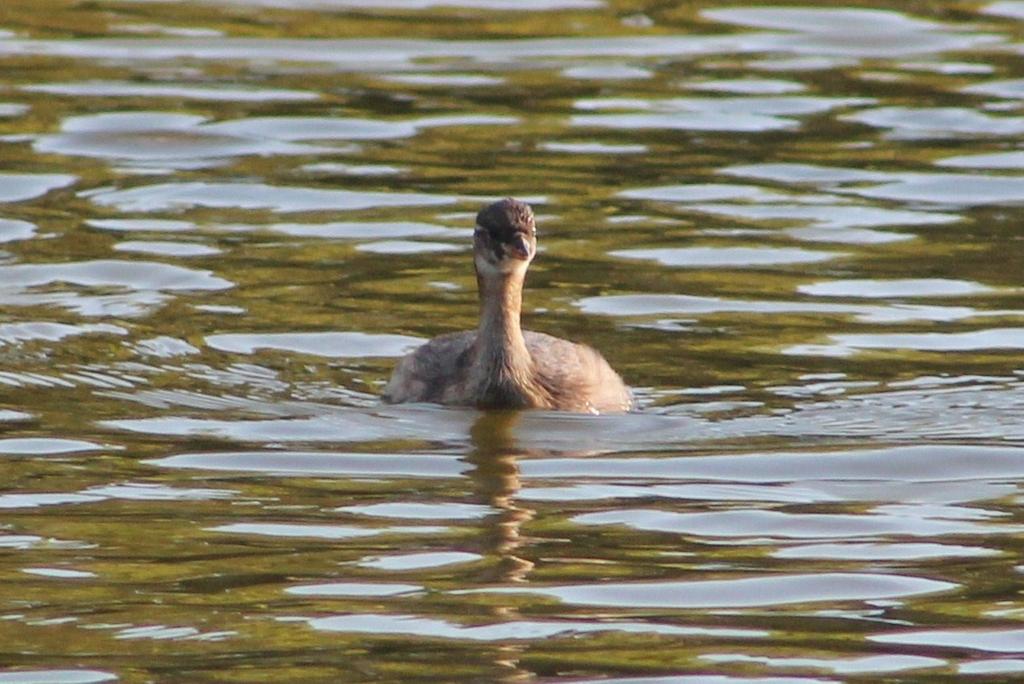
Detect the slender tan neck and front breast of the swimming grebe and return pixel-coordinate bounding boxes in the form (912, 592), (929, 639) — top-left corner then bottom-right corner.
(474, 273), (535, 405)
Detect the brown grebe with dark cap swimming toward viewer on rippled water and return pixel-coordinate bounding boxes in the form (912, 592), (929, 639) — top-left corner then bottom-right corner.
(384, 198), (633, 414)
